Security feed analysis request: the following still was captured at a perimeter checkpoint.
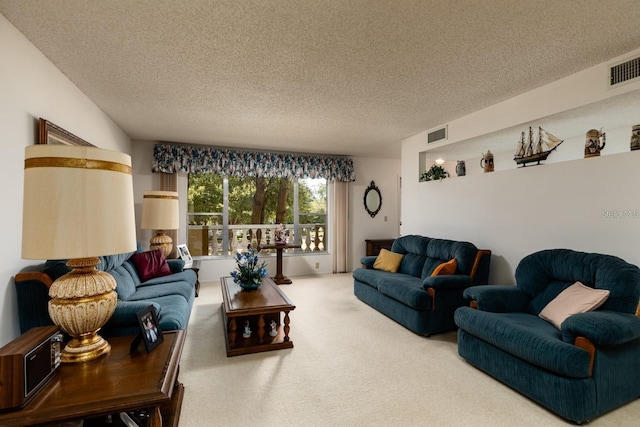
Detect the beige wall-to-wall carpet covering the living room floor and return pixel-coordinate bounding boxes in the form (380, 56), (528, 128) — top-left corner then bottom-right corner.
(180, 274), (640, 427)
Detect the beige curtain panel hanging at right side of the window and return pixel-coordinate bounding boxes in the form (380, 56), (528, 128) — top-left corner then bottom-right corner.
(331, 181), (349, 273)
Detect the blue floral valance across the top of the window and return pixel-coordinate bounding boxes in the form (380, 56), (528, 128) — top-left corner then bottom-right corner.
(151, 144), (356, 182)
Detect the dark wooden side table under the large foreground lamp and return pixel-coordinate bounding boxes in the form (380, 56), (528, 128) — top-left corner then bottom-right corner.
(0, 331), (186, 427)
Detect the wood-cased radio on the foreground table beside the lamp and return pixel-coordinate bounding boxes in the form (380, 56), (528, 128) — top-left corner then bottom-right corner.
(0, 326), (63, 411)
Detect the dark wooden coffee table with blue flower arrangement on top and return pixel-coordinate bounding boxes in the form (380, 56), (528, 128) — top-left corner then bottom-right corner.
(220, 277), (296, 357)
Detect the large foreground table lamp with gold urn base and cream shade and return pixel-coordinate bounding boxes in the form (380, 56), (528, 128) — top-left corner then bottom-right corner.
(22, 144), (136, 363)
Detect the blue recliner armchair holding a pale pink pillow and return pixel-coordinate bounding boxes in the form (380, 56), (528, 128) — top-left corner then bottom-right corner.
(455, 249), (640, 423)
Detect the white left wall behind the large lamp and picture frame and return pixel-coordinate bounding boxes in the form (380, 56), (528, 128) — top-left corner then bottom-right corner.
(0, 15), (131, 346)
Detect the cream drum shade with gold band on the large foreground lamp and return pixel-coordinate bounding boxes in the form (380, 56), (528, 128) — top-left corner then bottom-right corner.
(22, 144), (136, 259)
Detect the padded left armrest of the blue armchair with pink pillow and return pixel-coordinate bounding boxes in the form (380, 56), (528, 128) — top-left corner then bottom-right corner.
(464, 285), (529, 313)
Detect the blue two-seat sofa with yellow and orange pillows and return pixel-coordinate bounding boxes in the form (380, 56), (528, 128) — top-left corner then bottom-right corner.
(353, 235), (491, 336)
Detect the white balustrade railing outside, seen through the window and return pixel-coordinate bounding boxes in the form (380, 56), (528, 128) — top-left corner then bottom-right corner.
(187, 223), (327, 256)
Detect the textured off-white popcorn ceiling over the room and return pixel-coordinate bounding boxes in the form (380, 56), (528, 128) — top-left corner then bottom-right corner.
(0, 0), (640, 158)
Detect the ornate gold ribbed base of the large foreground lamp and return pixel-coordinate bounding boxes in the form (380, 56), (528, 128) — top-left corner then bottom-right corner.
(49, 258), (118, 363)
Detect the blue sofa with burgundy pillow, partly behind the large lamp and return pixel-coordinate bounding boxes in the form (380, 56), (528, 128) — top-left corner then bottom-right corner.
(15, 246), (197, 337)
